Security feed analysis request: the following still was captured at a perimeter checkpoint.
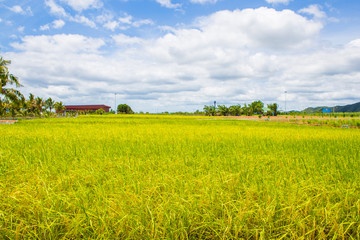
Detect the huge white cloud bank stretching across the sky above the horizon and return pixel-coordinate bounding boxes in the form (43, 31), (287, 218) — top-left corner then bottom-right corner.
(6, 8), (360, 112)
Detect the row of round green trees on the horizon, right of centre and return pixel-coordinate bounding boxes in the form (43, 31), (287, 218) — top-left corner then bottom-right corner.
(203, 101), (280, 116)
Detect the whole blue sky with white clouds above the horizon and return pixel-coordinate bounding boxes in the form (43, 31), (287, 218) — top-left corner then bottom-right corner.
(0, 0), (360, 112)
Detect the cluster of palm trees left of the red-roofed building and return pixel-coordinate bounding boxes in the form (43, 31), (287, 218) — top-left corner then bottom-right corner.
(0, 57), (65, 117)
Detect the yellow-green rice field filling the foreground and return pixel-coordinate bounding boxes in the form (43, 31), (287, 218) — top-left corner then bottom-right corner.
(0, 115), (360, 239)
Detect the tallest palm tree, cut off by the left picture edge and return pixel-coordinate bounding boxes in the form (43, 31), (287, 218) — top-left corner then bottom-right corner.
(0, 57), (22, 101)
